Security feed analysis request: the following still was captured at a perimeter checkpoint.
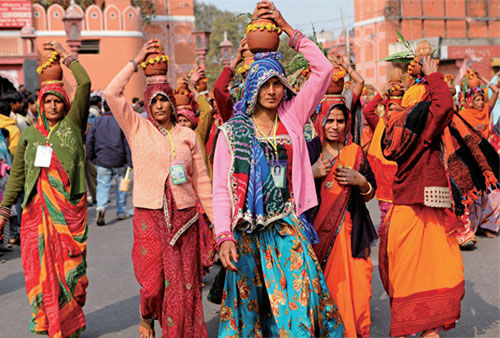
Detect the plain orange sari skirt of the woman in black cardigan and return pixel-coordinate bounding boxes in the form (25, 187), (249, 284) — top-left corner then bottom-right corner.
(325, 212), (373, 337)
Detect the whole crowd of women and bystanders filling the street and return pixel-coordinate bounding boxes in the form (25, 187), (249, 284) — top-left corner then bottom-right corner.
(0, 1), (500, 338)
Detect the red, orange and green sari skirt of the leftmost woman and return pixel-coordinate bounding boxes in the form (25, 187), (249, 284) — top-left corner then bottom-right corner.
(21, 156), (88, 338)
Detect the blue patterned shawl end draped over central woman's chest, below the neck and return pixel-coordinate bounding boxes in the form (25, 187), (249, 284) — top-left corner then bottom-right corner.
(220, 114), (293, 233)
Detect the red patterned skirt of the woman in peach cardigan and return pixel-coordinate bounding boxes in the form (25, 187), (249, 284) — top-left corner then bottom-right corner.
(132, 189), (207, 338)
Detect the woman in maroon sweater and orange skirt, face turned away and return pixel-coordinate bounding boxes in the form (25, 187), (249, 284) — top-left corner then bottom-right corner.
(379, 41), (464, 337)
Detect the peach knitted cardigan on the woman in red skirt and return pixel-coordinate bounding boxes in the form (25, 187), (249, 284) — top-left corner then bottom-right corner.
(104, 63), (213, 221)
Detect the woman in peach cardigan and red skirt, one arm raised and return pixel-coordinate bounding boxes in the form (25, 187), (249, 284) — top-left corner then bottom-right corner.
(105, 40), (212, 337)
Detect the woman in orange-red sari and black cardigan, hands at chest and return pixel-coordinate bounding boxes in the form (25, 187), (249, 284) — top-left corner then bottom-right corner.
(307, 103), (377, 337)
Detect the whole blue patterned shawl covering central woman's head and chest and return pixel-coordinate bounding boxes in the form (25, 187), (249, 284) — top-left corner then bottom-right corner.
(220, 53), (295, 232)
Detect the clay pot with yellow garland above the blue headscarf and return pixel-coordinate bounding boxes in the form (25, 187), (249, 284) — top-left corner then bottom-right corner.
(246, 19), (281, 54)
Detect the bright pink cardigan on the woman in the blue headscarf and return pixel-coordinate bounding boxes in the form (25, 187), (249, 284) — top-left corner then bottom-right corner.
(213, 37), (333, 234)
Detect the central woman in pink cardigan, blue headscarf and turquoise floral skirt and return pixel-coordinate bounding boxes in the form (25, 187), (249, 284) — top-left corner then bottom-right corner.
(213, 1), (343, 337)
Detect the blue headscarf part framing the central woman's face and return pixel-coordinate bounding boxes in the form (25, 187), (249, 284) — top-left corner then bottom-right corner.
(233, 52), (296, 115)
